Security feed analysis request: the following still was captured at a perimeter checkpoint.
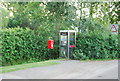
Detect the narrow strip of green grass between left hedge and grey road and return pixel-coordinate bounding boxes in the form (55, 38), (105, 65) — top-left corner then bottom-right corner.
(0, 60), (59, 73)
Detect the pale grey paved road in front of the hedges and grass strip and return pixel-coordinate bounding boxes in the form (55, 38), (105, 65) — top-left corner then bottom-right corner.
(2, 60), (118, 79)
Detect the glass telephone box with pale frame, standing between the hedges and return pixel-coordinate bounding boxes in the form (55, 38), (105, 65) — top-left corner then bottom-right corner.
(59, 30), (76, 58)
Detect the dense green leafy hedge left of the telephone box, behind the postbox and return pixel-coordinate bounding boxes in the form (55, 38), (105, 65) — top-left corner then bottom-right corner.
(0, 27), (58, 65)
